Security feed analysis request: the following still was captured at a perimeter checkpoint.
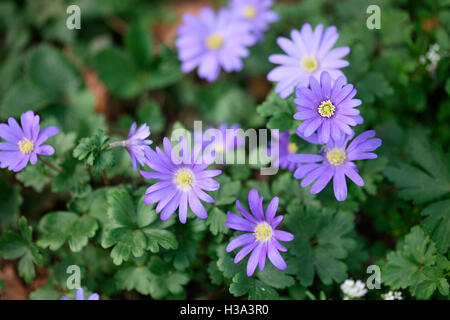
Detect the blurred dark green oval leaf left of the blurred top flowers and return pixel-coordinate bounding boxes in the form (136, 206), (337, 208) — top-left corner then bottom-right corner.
(94, 48), (141, 98)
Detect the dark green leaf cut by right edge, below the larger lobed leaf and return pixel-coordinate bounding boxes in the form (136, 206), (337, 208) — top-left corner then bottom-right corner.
(421, 200), (450, 253)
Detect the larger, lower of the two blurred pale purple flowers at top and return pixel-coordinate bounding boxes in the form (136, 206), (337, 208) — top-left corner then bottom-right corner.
(175, 7), (255, 82)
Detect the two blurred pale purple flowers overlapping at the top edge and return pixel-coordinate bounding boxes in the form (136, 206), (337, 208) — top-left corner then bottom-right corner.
(175, 0), (278, 82)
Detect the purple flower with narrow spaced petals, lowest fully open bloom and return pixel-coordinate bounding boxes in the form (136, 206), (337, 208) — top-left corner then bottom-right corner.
(225, 189), (294, 277)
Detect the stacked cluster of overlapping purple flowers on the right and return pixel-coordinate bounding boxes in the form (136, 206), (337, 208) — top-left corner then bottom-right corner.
(267, 23), (381, 201)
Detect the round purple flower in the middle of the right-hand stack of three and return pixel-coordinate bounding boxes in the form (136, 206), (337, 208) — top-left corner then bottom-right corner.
(294, 71), (364, 144)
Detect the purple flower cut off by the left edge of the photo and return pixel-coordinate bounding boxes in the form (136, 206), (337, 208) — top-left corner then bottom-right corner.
(0, 111), (59, 172)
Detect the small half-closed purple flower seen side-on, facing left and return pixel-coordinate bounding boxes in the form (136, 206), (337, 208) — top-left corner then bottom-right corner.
(123, 122), (152, 171)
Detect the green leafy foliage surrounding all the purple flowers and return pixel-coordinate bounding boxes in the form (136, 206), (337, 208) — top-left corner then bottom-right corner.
(0, 0), (450, 299)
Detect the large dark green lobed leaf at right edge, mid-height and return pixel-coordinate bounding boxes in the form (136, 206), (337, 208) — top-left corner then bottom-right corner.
(384, 134), (450, 203)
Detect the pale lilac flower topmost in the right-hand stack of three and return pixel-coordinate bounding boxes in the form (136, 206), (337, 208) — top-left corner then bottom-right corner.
(267, 23), (350, 98)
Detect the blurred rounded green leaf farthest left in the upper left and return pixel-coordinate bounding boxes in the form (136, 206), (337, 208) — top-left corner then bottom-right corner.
(28, 45), (79, 99)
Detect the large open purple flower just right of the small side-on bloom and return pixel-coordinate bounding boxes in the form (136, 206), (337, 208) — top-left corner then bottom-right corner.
(141, 138), (222, 223)
